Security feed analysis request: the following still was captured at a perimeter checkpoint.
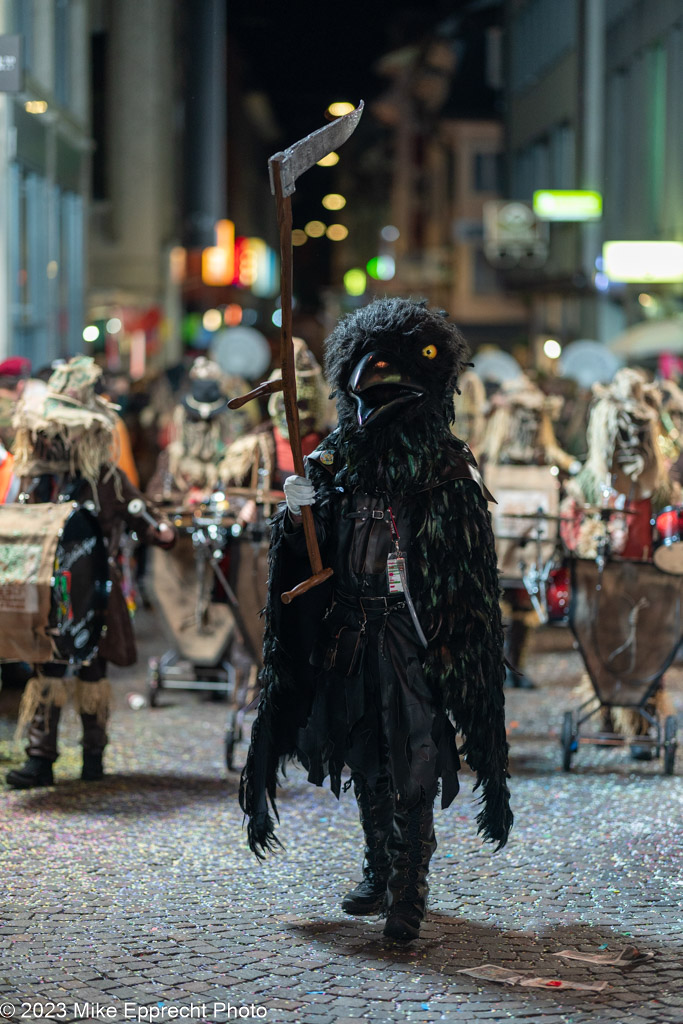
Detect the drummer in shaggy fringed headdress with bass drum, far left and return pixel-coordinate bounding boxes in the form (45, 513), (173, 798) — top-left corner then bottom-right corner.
(7, 356), (175, 788)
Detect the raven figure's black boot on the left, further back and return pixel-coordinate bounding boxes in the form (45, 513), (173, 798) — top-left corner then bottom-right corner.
(342, 775), (393, 915)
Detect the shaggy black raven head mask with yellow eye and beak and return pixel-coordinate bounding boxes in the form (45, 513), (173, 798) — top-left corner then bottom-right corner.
(325, 298), (468, 434)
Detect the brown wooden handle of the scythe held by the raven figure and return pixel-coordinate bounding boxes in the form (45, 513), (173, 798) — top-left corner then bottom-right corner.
(270, 158), (333, 604)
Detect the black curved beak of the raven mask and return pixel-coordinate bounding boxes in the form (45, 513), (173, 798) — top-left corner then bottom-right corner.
(348, 351), (425, 427)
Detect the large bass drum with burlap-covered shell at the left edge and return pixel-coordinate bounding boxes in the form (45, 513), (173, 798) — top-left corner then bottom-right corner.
(0, 502), (109, 664)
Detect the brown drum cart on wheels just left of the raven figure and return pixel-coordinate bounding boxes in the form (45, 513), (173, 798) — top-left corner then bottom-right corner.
(146, 493), (267, 770)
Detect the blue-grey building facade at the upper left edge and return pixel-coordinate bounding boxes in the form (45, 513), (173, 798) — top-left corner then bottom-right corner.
(0, 0), (91, 368)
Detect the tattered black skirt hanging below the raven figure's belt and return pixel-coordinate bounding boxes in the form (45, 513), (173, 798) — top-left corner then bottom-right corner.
(298, 594), (460, 807)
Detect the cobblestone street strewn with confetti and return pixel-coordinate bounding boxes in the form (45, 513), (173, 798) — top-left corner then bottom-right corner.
(0, 612), (683, 1024)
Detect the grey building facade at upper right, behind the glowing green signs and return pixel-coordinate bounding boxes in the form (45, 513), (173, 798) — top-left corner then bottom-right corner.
(505, 0), (683, 360)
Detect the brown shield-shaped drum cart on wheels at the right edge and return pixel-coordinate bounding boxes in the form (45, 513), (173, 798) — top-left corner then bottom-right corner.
(560, 551), (683, 775)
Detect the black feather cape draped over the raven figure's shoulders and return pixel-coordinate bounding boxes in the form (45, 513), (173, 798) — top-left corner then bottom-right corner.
(240, 416), (513, 857)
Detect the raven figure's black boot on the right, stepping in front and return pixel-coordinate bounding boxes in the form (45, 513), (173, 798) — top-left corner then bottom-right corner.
(384, 797), (436, 942)
